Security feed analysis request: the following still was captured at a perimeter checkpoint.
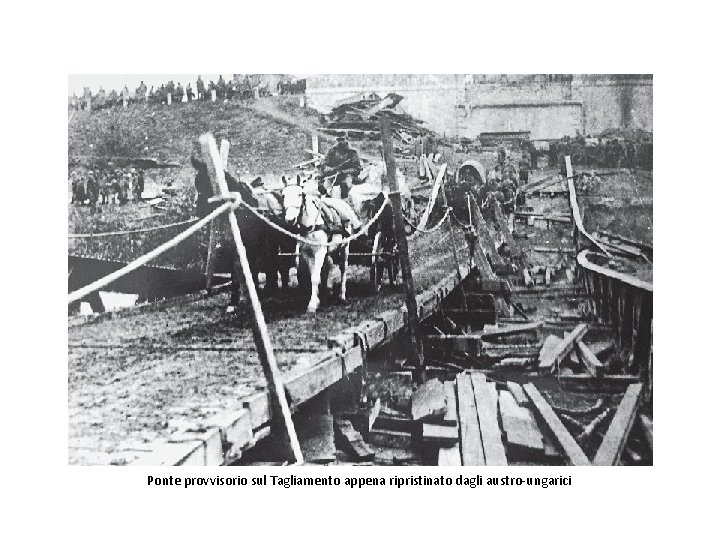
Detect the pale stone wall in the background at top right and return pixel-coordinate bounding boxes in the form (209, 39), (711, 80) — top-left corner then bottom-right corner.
(307, 75), (652, 139)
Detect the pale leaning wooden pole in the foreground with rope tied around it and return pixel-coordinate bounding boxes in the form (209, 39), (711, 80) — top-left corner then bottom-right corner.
(200, 133), (303, 465)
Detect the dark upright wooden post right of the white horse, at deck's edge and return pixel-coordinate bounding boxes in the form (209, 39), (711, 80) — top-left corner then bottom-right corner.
(380, 116), (425, 382)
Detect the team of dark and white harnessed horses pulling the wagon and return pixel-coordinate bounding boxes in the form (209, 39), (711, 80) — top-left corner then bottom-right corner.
(191, 159), (402, 313)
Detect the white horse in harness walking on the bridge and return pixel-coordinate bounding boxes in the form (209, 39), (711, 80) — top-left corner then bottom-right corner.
(282, 184), (359, 313)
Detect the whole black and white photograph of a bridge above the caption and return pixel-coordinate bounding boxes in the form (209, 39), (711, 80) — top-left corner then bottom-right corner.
(67, 74), (653, 466)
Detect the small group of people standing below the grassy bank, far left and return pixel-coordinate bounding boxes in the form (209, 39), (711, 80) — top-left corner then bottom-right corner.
(70, 166), (145, 207)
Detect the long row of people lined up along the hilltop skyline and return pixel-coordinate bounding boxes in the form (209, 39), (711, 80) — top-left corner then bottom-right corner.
(68, 75), (282, 110)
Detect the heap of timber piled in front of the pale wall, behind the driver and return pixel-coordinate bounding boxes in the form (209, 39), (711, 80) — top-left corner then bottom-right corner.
(320, 93), (431, 143)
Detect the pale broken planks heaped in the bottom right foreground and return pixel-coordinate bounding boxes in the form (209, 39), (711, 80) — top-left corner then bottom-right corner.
(436, 371), (652, 466)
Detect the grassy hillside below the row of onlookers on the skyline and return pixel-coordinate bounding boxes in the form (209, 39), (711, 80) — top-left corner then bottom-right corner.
(68, 98), (326, 268)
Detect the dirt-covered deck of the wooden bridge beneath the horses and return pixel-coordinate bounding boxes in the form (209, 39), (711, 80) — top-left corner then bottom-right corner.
(68, 226), (467, 464)
